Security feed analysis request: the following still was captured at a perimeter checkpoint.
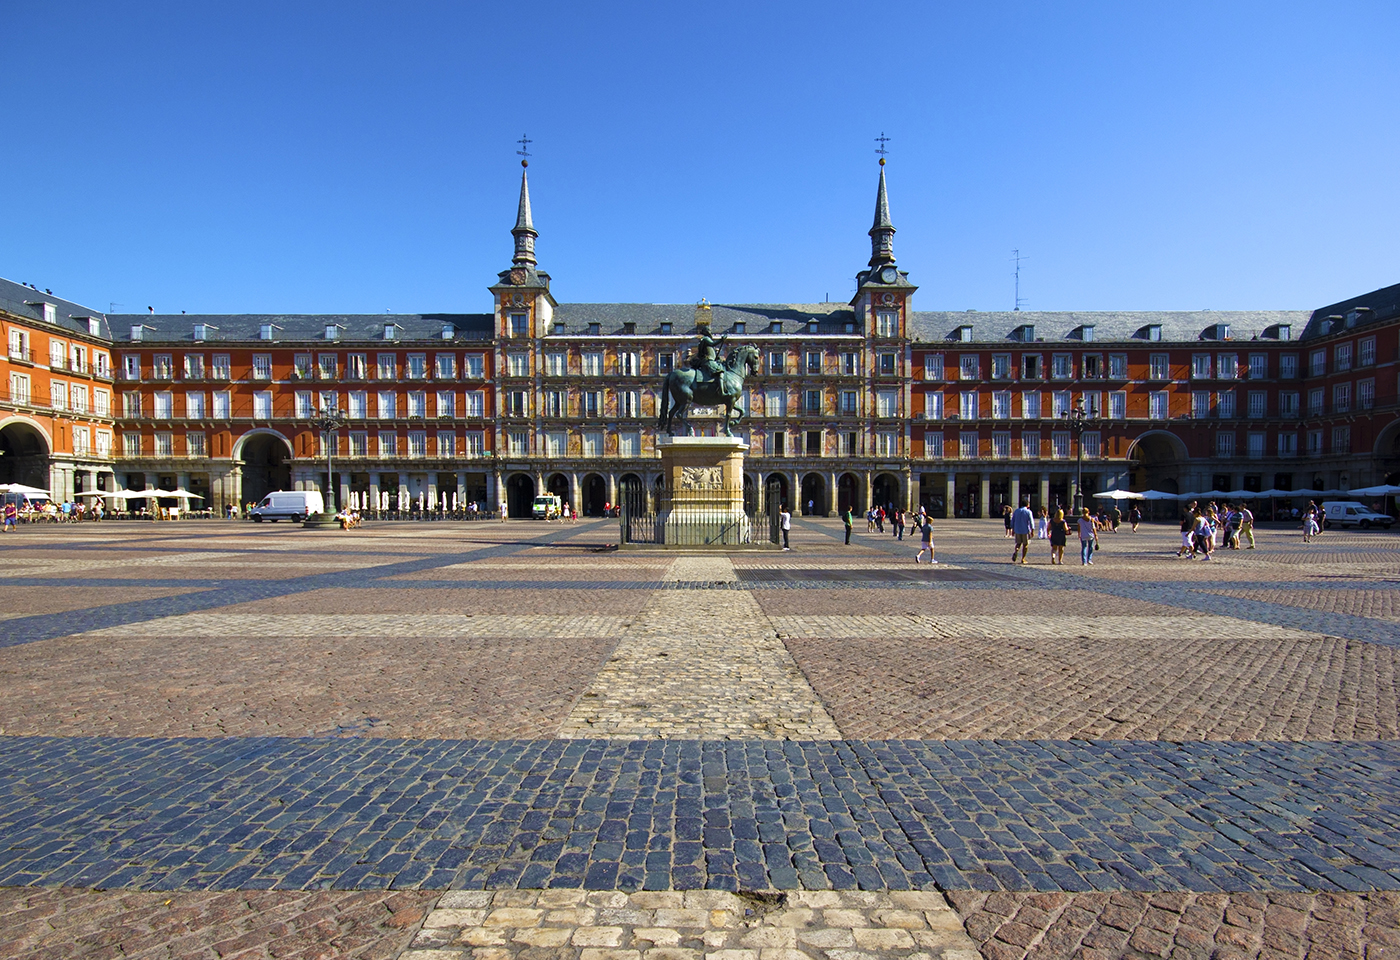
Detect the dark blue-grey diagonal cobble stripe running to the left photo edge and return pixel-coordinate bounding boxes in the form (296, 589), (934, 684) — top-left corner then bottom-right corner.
(0, 530), (590, 648)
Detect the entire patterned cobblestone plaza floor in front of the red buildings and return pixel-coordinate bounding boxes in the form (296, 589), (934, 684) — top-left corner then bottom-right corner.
(0, 519), (1400, 960)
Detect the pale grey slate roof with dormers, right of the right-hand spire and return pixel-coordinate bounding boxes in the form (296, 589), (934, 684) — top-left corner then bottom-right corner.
(909, 311), (1309, 344)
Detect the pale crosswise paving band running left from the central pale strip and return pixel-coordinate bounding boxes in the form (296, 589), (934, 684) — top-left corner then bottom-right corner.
(80, 610), (631, 638)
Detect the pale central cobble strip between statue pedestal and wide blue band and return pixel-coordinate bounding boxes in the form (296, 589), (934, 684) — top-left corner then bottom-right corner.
(560, 570), (840, 739)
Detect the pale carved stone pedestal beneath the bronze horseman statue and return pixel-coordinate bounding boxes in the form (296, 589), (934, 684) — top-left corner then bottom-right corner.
(657, 437), (753, 547)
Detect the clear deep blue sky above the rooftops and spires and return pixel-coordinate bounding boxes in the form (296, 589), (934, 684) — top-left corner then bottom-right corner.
(0, 0), (1400, 313)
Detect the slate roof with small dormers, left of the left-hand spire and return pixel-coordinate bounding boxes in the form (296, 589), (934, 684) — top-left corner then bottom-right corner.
(108, 313), (493, 343)
